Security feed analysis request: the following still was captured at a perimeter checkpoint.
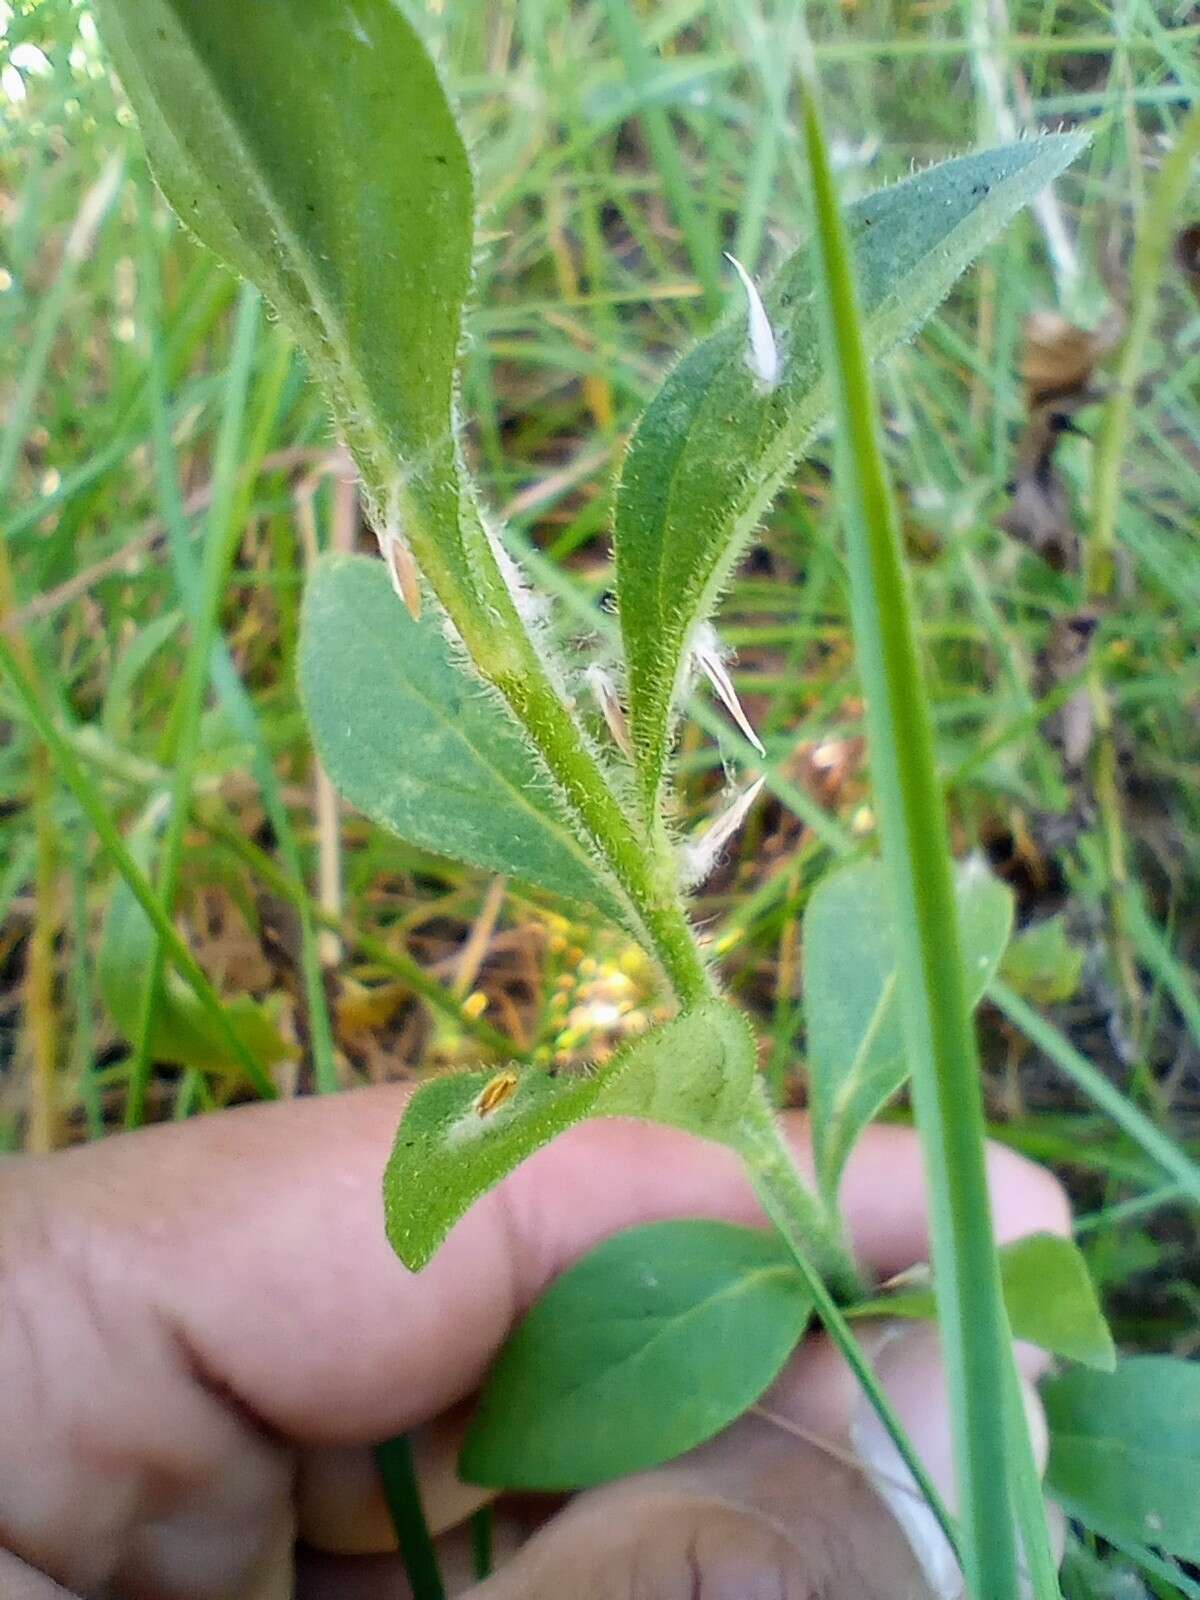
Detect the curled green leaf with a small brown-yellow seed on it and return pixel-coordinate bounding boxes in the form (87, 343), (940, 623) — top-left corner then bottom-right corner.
(384, 1000), (755, 1270)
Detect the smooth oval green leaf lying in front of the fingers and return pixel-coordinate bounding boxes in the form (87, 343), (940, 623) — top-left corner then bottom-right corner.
(459, 1222), (811, 1490)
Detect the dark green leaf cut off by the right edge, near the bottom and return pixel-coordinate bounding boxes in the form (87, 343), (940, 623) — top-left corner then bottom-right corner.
(1042, 1355), (1200, 1562)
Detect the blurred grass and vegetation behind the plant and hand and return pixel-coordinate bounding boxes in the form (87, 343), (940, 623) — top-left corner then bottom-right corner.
(0, 0), (1200, 1594)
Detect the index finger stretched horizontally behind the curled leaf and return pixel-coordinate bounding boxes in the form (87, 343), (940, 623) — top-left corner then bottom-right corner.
(0, 1086), (1067, 1443)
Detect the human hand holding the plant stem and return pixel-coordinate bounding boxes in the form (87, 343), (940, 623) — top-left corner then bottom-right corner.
(0, 1086), (1067, 1600)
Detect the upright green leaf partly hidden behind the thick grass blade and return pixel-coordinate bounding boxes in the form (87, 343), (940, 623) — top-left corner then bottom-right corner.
(803, 859), (1013, 1200)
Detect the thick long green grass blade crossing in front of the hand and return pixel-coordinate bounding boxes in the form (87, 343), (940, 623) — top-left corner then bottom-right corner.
(805, 65), (1045, 1600)
